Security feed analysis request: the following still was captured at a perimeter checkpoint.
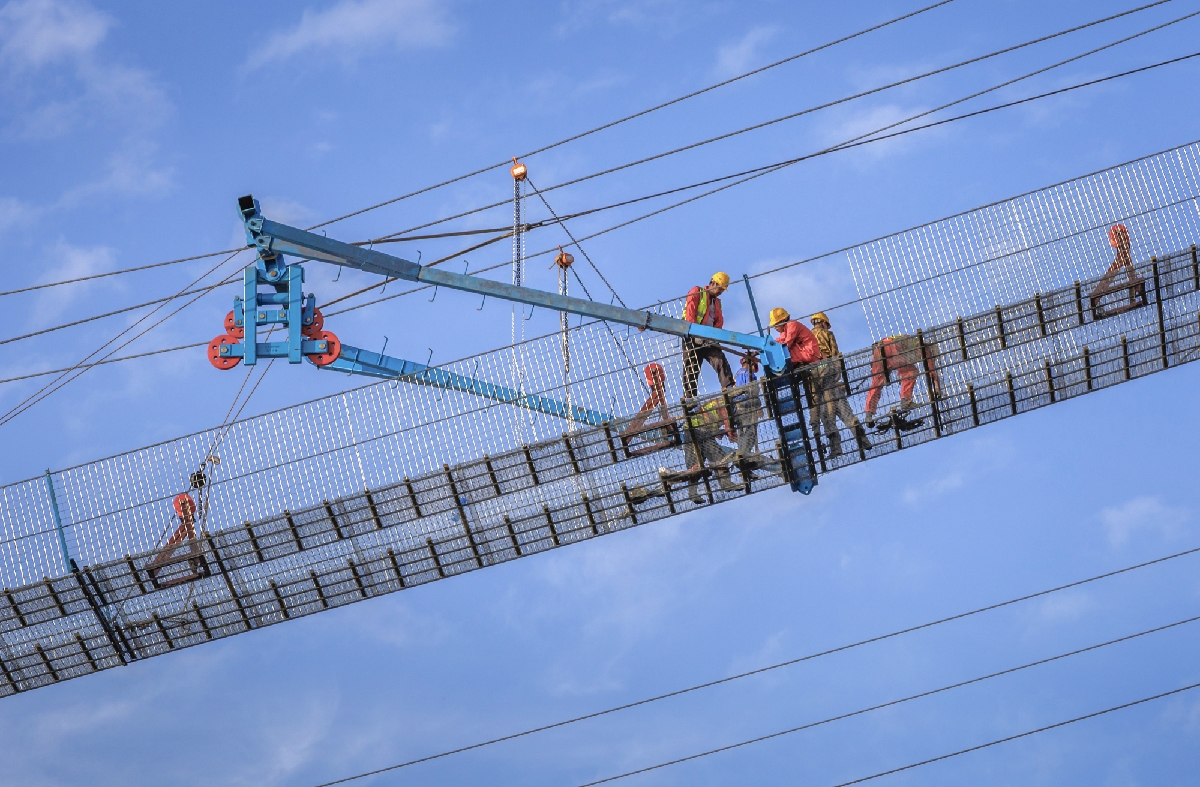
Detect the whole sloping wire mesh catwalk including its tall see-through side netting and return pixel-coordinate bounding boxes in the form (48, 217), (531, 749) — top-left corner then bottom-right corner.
(0, 145), (1200, 695)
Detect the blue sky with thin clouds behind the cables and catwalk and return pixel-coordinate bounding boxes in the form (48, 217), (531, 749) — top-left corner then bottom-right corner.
(0, 0), (1200, 786)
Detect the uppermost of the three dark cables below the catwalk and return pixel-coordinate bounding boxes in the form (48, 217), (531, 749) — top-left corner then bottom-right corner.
(307, 547), (1200, 787)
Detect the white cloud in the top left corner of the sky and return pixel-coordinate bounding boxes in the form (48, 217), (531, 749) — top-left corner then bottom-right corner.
(0, 0), (112, 71)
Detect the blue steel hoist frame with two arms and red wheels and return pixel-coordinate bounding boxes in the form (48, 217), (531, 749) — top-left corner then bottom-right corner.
(209, 196), (815, 493)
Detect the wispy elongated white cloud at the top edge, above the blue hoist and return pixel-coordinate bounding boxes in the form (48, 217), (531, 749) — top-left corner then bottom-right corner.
(247, 0), (454, 68)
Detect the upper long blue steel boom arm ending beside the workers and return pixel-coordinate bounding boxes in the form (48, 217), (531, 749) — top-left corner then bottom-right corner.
(238, 197), (787, 373)
